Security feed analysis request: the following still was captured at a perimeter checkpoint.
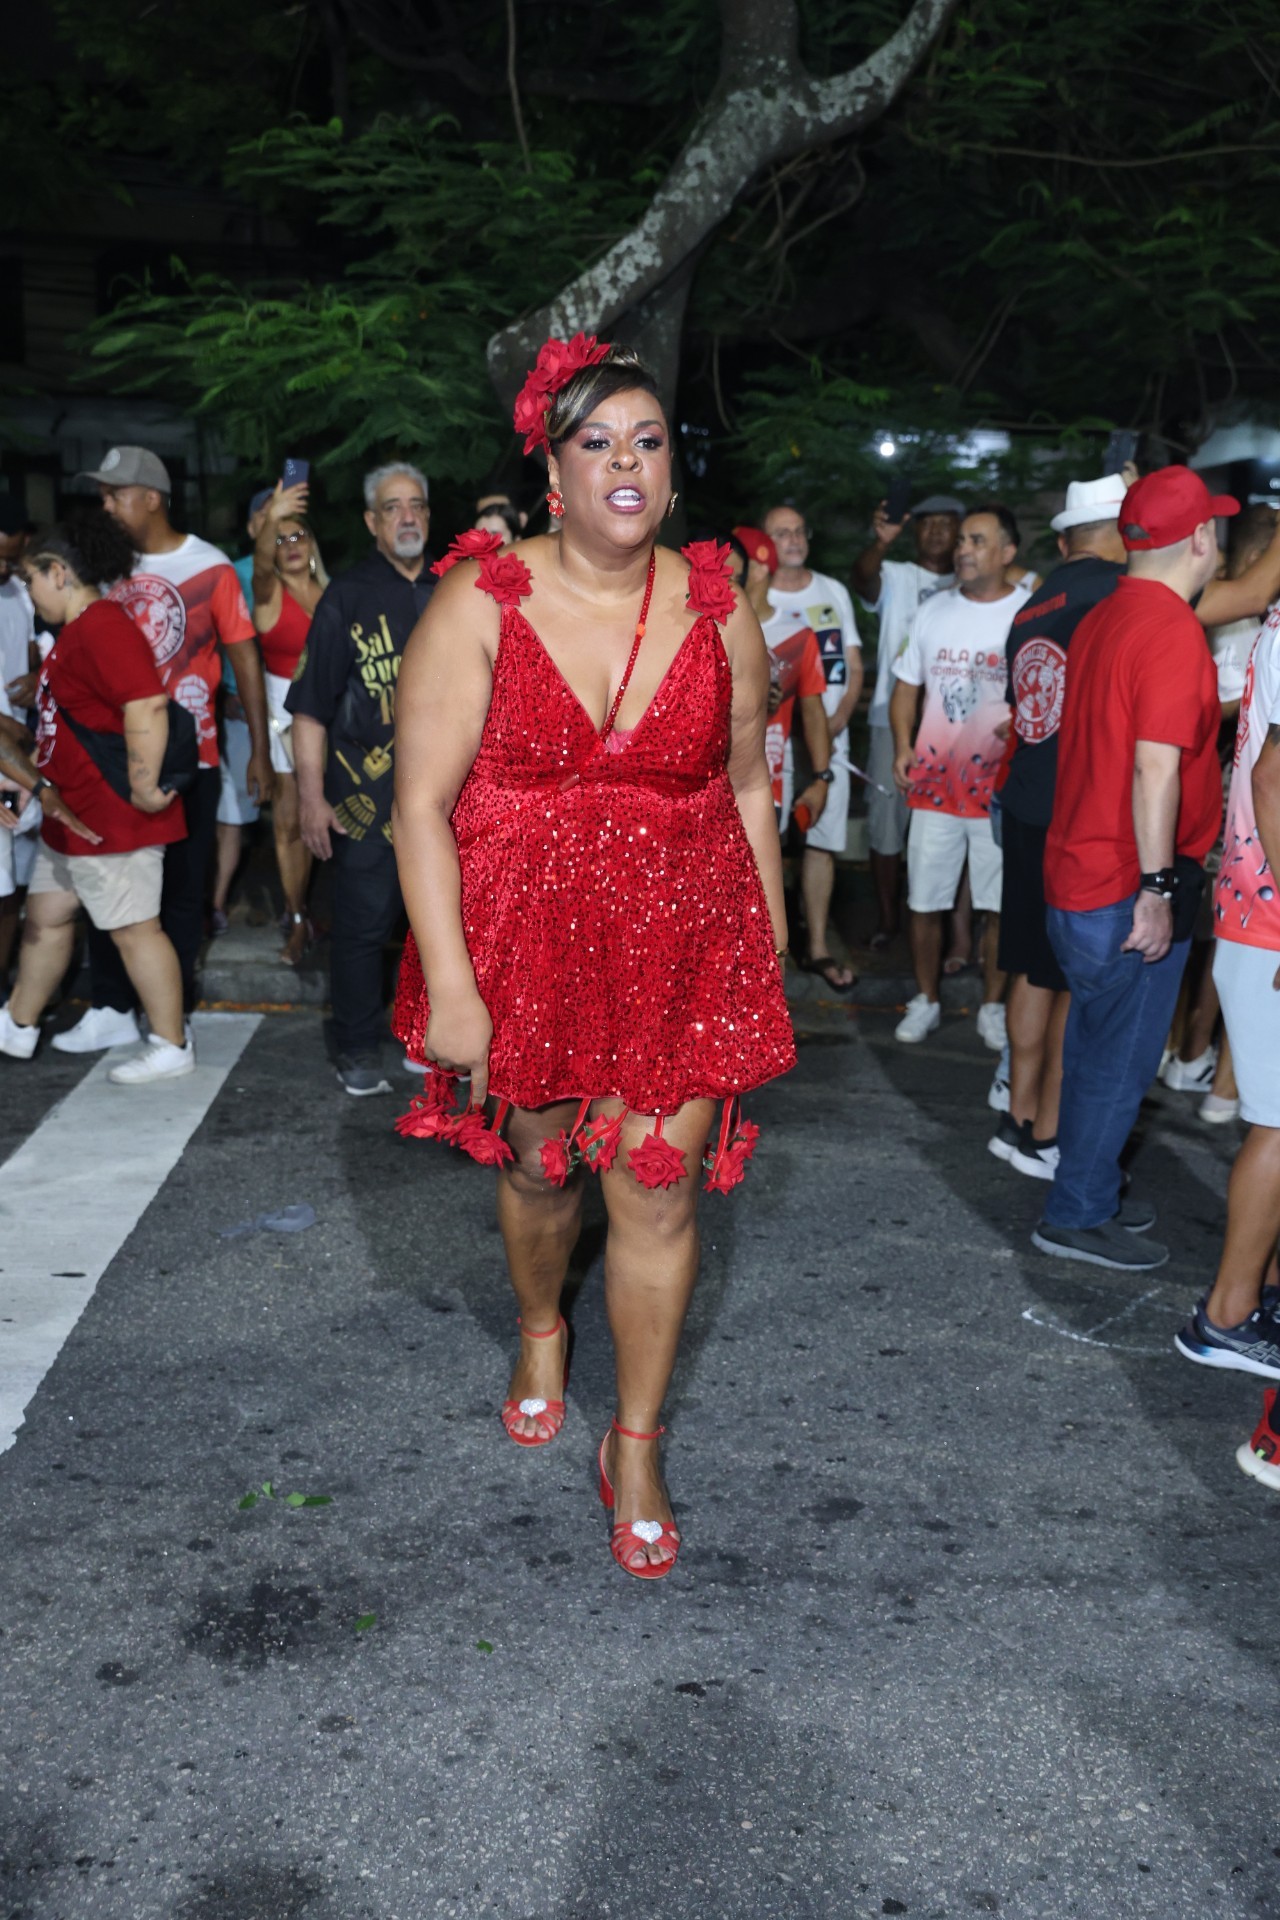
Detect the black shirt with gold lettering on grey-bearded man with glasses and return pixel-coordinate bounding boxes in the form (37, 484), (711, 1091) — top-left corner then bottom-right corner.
(284, 549), (436, 841)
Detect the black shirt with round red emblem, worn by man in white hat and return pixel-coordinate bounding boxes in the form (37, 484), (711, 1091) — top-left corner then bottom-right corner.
(1000, 553), (1125, 828)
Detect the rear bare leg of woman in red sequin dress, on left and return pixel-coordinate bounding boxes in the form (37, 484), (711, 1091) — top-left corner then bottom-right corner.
(497, 1104), (581, 1438)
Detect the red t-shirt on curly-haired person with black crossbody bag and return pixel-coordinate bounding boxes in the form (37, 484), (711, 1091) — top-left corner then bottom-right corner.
(36, 599), (186, 854)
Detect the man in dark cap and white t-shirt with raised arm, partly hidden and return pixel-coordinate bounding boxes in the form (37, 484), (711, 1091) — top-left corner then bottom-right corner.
(854, 493), (965, 947)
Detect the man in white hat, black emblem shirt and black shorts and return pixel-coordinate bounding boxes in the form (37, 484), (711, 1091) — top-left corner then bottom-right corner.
(990, 474), (1125, 1181)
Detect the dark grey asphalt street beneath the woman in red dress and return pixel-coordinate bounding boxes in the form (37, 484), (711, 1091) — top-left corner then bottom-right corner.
(0, 1008), (1280, 1920)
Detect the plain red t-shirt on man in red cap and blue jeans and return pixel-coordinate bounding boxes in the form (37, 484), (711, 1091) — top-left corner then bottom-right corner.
(1044, 576), (1222, 914)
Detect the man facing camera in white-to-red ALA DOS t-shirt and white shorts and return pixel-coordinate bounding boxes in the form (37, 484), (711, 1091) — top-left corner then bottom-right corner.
(889, 505), (1027, 1052)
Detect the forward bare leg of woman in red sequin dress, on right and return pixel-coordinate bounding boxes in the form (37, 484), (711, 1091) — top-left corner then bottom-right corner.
(601, 1100), (714, 1567)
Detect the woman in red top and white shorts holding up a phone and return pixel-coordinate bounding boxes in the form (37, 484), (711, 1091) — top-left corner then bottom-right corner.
(253, 482), (328, 966)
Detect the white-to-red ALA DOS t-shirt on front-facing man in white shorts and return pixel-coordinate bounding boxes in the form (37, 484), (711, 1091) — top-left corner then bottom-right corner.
(894, 588), (1027, 820)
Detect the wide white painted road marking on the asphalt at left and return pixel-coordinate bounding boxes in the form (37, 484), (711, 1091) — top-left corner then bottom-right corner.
(0, 1014), (263, 1453)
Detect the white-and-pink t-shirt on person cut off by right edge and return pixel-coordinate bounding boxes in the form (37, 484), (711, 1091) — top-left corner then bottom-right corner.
(1213, 607), (1280, 950)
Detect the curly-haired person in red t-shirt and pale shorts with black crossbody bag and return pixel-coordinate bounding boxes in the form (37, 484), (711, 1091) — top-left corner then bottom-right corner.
(0, 509), (196, 1085)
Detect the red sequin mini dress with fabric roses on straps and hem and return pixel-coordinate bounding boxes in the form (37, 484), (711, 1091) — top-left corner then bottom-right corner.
(393, 536), (796, 1190)
